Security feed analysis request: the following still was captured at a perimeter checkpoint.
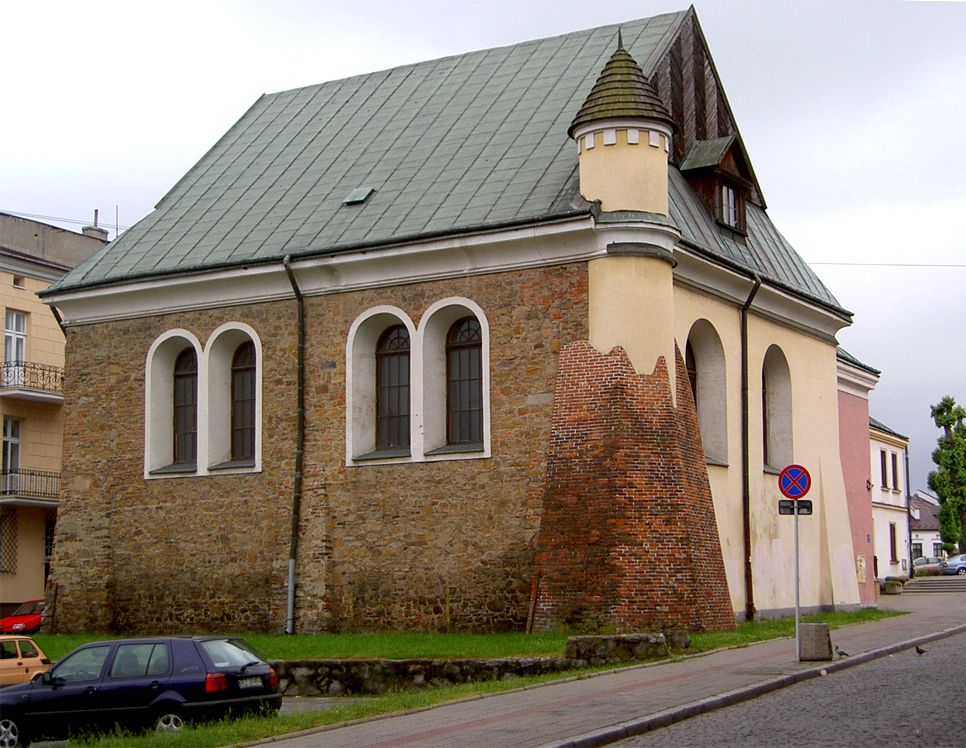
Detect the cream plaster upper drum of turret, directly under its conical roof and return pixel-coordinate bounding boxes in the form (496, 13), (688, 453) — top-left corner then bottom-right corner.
(578, 129), (668, 215)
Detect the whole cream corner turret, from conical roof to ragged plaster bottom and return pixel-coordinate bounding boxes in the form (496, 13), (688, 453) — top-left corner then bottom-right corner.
(568, 36), (680, 386)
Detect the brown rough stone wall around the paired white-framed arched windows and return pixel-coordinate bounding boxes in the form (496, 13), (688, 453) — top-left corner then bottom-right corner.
(48, 263), (587, 632)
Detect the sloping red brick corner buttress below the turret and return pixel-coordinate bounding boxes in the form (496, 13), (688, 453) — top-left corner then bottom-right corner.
(534, 341), (735, 632)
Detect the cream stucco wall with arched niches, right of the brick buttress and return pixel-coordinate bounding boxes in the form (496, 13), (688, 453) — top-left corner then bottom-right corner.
(674, 284), (859, 615)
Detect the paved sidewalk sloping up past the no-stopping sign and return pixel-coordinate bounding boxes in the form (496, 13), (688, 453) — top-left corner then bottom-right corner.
(263, 593), (966, 748)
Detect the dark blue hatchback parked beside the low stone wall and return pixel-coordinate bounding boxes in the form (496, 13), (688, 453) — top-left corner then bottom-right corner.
(0, 636), (282, 748)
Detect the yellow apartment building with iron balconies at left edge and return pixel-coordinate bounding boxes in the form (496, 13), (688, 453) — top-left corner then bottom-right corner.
(0, 213), (107, 614)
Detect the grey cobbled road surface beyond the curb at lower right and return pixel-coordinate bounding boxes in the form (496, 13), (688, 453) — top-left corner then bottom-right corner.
(615, 633), (966, 748)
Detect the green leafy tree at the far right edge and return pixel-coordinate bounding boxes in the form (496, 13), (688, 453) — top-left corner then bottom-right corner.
(929, 395), (966, 552)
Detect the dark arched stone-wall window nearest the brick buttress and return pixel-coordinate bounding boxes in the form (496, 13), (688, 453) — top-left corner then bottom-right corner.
(446, 317), (483, 444)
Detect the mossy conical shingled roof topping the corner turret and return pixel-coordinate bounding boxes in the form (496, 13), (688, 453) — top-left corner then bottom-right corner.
(567, 35), (674, 137)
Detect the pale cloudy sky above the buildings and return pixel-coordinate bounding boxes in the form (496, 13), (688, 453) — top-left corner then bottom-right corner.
(0, 0), (966, 490)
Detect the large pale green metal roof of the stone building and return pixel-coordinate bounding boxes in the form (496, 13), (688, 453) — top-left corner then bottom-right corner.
(52, 11), (847, 315)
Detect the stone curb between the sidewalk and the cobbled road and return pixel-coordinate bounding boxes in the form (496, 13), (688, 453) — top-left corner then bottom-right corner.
(542, 624), (966, 748)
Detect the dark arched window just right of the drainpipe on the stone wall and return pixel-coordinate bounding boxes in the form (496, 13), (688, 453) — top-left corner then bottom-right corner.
(376, 325), (409, 449)
